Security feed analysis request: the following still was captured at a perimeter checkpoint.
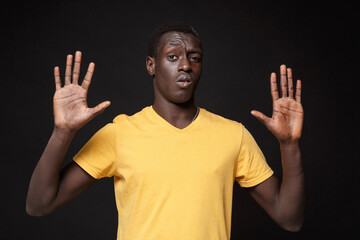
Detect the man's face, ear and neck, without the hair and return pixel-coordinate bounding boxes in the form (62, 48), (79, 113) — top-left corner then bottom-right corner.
(146, 32), (202, 128)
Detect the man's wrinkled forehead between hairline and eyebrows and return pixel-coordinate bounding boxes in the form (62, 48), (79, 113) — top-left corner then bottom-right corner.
(159, 32), (202, 51)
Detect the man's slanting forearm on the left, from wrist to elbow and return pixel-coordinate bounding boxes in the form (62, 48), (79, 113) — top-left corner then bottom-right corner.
(26, 127), (75, 215)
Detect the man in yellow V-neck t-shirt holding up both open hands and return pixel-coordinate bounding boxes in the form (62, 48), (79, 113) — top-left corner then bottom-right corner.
(27, 24), (304, 240)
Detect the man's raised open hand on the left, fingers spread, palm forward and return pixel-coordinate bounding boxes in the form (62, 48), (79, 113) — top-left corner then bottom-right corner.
(54, 51), (110, 132)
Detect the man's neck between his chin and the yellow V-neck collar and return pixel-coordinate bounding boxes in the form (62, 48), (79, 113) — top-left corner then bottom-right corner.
(153, 98), (197, 129)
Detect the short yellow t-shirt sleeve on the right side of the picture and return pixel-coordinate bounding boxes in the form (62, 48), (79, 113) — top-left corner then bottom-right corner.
(235, 126), (274, 187)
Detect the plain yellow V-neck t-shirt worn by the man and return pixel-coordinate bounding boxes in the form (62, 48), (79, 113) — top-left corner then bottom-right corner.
(74, 106), (273, 240)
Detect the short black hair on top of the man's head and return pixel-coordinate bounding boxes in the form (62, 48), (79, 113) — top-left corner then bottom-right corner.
(148, 22), (200, 58)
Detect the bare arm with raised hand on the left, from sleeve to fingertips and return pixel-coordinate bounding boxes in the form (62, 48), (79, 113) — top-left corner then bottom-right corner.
(26, 52), (110, 216)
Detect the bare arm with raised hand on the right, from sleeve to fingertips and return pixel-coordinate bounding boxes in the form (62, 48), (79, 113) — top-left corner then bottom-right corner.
(248, 65), (305, 231)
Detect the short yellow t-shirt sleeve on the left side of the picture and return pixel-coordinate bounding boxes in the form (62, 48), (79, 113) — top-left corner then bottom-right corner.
(73, 123), (117, 179)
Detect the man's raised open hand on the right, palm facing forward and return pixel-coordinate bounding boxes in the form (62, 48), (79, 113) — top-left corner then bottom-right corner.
(251, 65), (304, 143)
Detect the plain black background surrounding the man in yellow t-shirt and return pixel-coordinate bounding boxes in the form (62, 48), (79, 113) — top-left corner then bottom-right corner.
(0, 0), (359, 239)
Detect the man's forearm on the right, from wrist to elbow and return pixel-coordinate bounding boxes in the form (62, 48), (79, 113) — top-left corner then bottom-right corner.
(277, 142), (305, 230)
